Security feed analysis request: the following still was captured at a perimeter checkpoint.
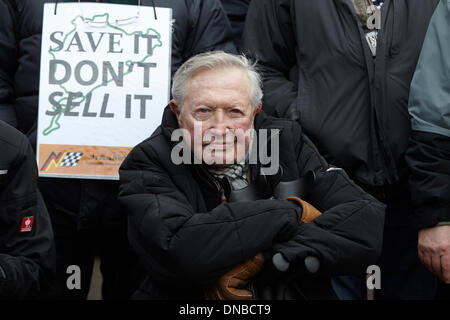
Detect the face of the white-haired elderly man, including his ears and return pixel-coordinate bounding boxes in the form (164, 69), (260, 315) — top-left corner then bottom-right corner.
(170, 68), (261, 165)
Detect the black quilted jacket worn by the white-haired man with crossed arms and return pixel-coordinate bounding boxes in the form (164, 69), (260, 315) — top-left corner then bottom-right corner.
(119, 108), (384, 298)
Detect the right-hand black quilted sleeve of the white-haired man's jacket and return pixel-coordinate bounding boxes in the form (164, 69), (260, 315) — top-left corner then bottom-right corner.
(274, 122), (385, 275)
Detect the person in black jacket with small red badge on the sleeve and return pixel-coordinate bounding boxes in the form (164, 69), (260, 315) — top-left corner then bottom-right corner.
(0, 120), (55, 300)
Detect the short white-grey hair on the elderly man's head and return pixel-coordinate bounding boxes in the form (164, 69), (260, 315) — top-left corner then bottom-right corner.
(172, 51), (263, 109)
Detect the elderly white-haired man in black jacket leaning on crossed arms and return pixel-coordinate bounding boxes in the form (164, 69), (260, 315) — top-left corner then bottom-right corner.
(119, 52), (384, 299)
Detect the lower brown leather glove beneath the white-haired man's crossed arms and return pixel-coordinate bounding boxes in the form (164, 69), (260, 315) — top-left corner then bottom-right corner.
(205, 253), (264, 300)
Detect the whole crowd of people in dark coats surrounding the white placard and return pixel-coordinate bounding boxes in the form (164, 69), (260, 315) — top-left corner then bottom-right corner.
(0, 0), (450, 300)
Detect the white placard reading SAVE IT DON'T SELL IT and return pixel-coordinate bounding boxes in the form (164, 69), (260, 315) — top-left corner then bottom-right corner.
(37, 3), (172, 179)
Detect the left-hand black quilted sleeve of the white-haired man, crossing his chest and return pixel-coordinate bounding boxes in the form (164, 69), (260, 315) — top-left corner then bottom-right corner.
(119, 145), (301, 285)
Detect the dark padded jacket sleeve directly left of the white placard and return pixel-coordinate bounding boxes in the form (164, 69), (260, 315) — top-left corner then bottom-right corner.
(0, 0), (44, 142)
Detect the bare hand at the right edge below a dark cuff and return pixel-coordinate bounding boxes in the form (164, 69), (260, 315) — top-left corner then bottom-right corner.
(418, 226), (450, 283)
